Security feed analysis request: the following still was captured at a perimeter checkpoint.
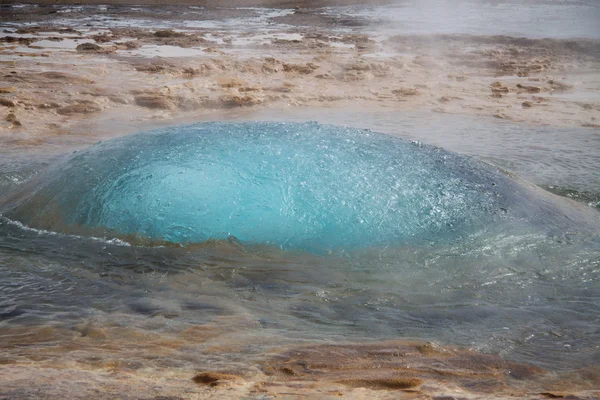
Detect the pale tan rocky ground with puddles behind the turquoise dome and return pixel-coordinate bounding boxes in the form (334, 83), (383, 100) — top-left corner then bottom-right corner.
(0, 3), (600, 148)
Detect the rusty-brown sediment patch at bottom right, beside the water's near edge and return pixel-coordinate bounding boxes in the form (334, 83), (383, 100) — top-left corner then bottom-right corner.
(263, 341), (598, 398)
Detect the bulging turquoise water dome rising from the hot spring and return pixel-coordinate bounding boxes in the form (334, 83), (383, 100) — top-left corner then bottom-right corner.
(5, 122), (514, 251)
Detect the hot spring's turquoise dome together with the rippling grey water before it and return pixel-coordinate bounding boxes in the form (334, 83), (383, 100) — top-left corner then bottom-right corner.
(0, 122), (600, 386)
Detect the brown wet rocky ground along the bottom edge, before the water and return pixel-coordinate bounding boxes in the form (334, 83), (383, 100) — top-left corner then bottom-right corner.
(0, 318), (600, 400)
